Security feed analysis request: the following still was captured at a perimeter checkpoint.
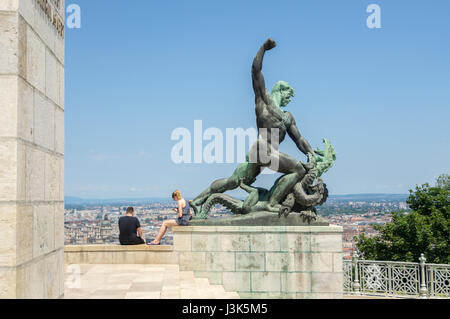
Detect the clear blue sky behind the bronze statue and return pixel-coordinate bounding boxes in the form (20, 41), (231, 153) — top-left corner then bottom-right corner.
(65, 0), (450, 198)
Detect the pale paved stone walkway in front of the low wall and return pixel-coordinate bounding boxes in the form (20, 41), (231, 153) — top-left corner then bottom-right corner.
(64, 264), (239, 299)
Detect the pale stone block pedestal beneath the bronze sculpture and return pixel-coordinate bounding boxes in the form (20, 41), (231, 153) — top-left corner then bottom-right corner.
(173, 226), (343, 298)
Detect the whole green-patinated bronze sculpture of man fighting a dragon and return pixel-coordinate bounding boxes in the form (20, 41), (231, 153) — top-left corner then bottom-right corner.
(190, 39), (336, 224)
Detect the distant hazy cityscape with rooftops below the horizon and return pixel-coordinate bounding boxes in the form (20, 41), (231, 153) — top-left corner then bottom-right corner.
(65, 194), (408, 259)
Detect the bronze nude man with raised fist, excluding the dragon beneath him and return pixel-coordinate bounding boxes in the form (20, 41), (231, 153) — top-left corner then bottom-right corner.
(191, 39), (315, 218)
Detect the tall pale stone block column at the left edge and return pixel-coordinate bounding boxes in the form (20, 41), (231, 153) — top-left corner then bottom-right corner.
(0, 0), (64, 298)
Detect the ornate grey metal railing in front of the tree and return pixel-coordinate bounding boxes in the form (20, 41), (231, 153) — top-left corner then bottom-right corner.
(344, 252), (450, 298)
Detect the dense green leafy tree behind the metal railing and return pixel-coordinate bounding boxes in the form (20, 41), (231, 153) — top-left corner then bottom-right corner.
(355, 174), (450, 264)
